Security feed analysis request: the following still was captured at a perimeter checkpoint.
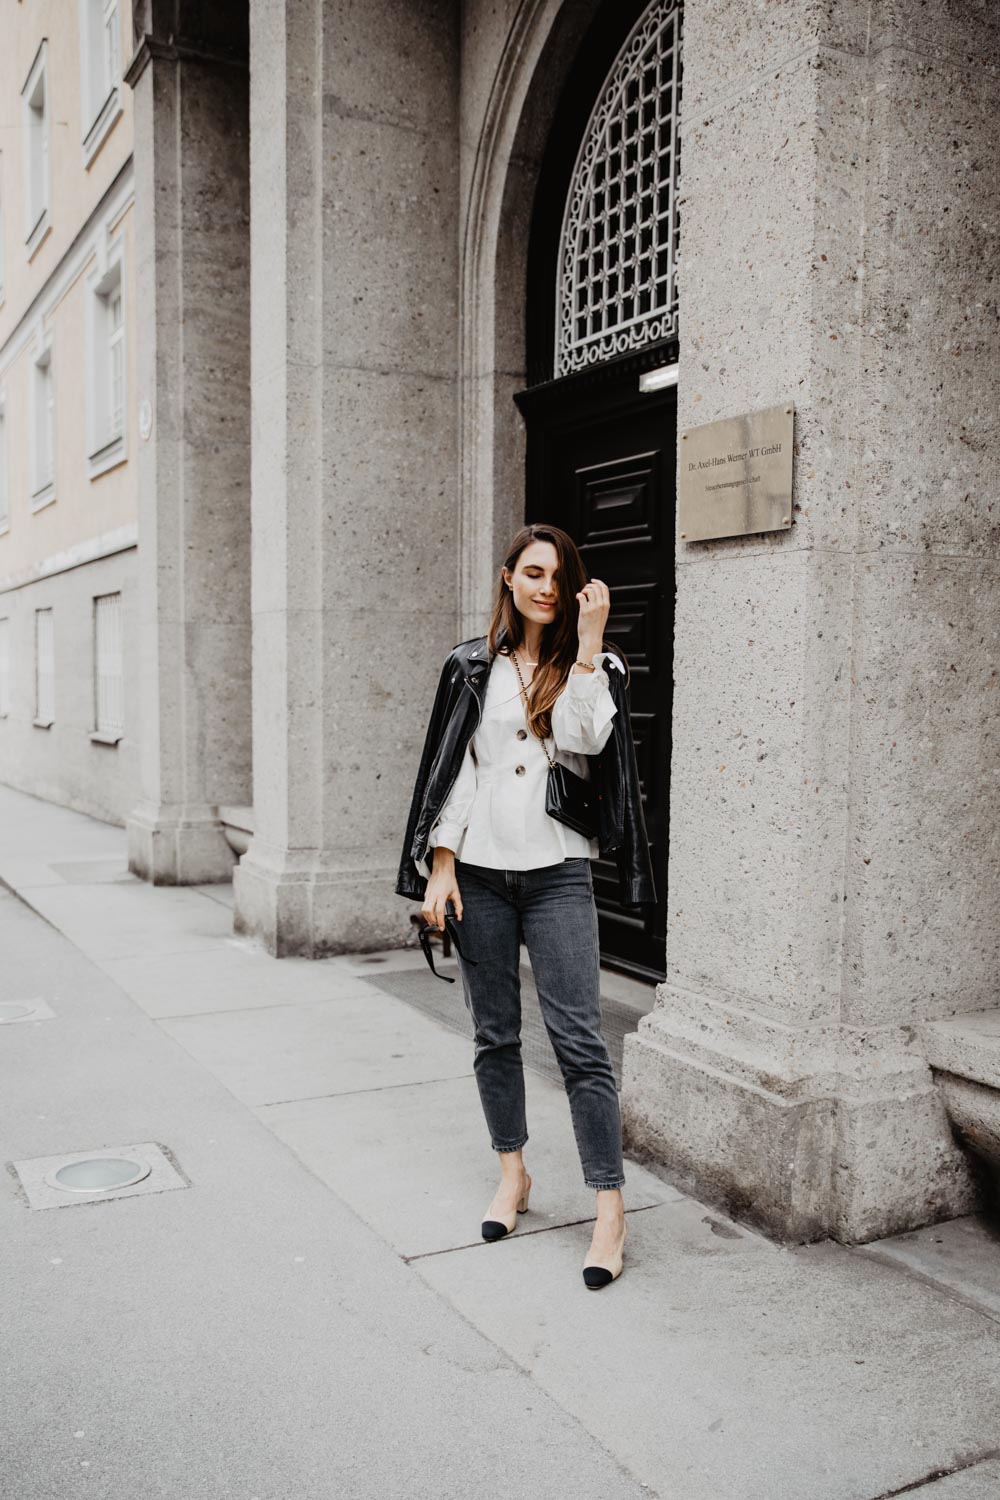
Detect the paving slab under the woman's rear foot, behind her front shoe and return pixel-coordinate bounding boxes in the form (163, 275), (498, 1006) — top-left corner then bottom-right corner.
(258, 1074), (684, 1256)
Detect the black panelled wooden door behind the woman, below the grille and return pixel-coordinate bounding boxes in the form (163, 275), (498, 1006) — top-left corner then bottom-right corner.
(517, 351), (676, 980)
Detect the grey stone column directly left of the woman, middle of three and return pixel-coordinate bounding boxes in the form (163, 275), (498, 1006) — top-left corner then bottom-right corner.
(234, 0), (459, 957)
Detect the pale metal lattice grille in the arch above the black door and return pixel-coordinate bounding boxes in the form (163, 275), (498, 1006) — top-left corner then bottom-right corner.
(556, 0), (681, 375)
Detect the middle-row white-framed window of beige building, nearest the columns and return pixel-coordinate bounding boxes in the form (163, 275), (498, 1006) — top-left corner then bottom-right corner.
(87, 245), (129, 479)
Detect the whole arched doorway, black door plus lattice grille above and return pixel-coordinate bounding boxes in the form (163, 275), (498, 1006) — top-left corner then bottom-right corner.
(514, 0), (681, 980)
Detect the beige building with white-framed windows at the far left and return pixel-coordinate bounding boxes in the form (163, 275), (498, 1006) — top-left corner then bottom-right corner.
(0, 0), (139, 822)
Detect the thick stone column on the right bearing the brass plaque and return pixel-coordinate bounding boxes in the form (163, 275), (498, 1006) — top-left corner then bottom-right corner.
(622, 0), (1000, 1242)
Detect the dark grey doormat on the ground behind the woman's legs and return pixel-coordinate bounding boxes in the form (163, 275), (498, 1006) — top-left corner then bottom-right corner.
(364, 954), (645, 1089)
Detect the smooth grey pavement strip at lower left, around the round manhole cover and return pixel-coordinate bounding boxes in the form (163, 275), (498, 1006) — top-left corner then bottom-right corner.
(0, 893), (646, 1500)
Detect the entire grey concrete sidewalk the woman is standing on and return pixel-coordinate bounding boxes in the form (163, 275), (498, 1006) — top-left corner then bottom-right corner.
(0, 788), (1000, 1500)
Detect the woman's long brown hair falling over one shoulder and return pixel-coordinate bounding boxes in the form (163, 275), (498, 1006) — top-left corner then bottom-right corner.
(487, 521), (628, 740)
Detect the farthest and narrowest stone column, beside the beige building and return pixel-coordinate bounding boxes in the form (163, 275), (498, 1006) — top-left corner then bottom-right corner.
(126, 0), (250, 885)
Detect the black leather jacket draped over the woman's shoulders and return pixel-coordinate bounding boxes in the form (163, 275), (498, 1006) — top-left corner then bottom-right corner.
(396, 636), (657, 906)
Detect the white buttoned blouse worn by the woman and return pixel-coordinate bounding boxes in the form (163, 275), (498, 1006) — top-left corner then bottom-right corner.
(415, 651), (625, 879)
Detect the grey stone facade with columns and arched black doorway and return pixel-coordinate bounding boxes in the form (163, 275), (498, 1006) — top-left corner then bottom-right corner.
(15, 0), (1000, 1242)
